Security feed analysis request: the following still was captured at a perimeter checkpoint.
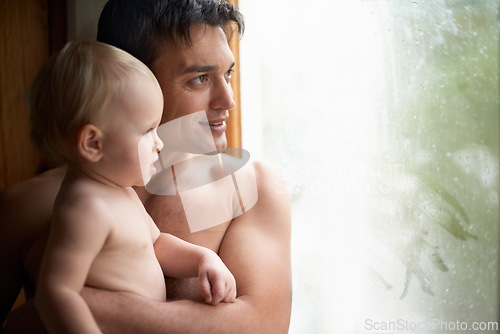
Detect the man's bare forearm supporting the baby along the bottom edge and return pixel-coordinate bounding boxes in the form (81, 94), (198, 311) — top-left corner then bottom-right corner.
(82, 288), (289, 334)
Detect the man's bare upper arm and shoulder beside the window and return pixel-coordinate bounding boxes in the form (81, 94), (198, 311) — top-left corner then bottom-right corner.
(215, 163), (292, 333)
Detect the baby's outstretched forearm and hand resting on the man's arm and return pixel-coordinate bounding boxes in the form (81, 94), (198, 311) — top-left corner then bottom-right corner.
(154, 233), (236, 305)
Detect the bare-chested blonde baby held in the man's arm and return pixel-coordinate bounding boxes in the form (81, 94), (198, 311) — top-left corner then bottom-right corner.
(30, 42), (236, 333)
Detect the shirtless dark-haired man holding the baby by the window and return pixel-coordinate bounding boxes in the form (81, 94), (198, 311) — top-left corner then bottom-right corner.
(0, 0), (291, 333)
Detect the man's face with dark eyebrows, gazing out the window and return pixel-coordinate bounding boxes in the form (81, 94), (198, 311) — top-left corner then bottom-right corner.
(152, 24), (235, 151)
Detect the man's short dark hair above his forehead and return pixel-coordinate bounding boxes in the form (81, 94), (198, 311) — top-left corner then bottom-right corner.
(97, 0), (244, 68)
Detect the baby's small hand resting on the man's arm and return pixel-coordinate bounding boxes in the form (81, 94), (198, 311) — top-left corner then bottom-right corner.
(198, 251), (236, 305)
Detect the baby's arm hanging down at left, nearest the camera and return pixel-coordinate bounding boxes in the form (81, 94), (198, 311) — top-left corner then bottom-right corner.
(35, 200), (109, 333)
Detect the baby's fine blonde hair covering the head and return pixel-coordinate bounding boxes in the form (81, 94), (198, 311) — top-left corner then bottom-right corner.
(30, 41), (158, 166)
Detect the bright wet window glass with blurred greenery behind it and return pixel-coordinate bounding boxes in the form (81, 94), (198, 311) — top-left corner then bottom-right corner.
(239, 0), (500, 333)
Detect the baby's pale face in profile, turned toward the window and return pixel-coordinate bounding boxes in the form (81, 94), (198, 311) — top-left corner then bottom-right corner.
(103, 74), (163, 187)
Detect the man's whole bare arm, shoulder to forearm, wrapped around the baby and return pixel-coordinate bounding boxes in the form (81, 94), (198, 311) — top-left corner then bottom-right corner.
(83, 163), (292, 334)
